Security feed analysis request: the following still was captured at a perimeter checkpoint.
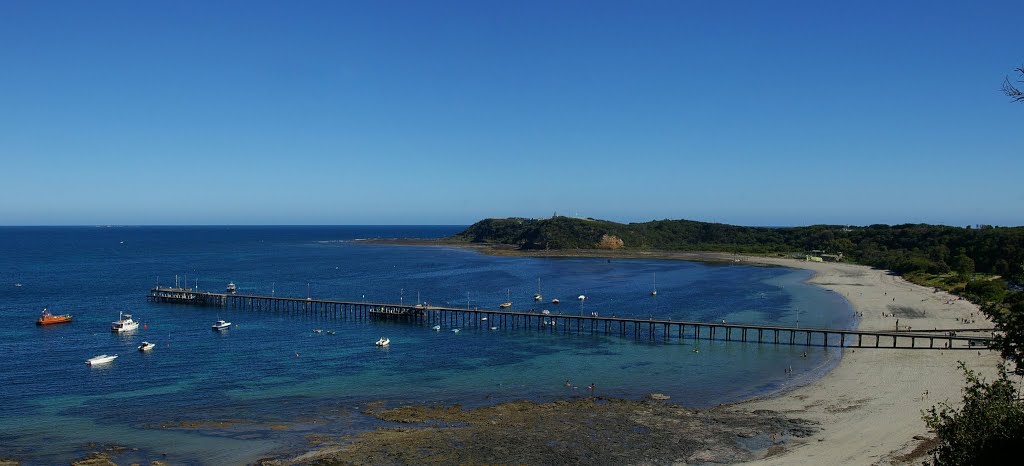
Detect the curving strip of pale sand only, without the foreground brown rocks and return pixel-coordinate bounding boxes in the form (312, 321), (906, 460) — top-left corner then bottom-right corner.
(350, 240), (1000, 464)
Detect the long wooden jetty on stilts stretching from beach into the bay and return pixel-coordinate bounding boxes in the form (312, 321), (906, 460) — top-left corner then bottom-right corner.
(147, 287), (992, 349)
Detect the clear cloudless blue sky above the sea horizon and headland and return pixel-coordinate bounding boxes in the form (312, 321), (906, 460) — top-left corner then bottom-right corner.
(0, 0), (1024, 225)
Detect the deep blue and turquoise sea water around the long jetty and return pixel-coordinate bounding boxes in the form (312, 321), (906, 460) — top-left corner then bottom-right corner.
(0, 226), (853, 464)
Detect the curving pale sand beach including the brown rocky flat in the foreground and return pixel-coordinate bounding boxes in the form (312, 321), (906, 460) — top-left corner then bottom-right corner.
(265, 247), (999, 465)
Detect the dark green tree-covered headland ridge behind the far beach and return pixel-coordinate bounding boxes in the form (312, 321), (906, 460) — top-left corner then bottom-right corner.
(455, 217), (1024, 281)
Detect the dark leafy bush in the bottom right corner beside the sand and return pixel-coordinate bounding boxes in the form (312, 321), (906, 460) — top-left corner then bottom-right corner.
(924, 363), (1024, 465)
